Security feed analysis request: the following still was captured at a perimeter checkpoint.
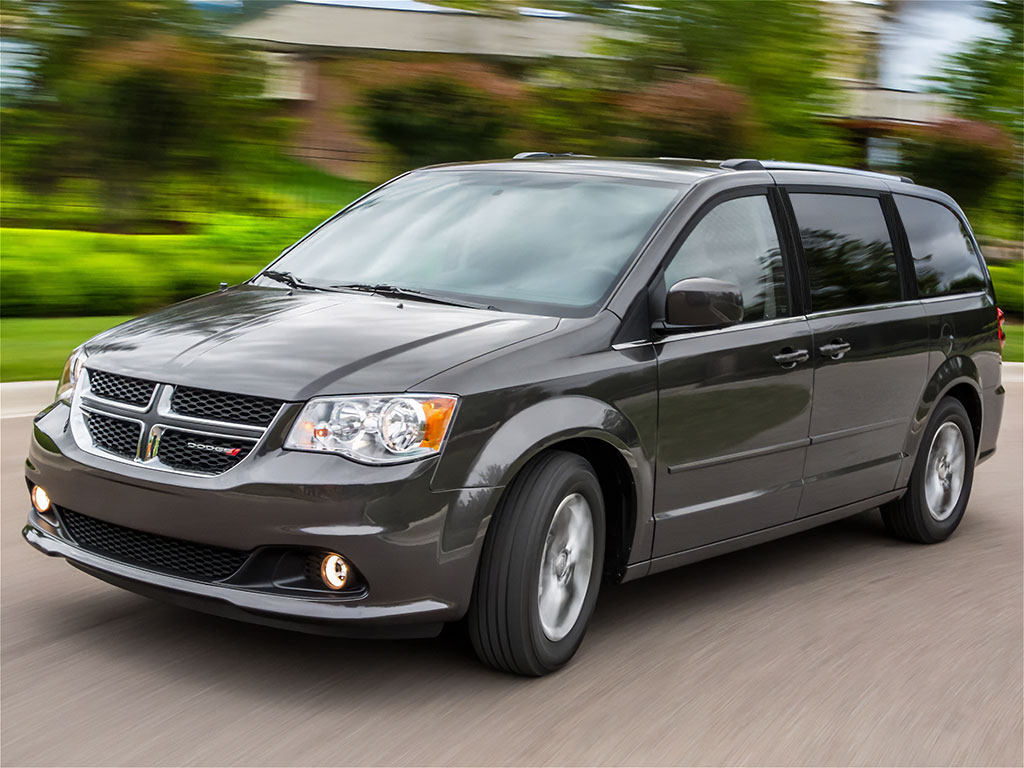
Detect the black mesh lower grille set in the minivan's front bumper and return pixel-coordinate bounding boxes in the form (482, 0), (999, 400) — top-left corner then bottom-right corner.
(59, 509), (249, 582)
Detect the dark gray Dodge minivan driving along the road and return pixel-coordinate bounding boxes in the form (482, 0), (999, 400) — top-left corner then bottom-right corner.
(24, 159), (1004, 675)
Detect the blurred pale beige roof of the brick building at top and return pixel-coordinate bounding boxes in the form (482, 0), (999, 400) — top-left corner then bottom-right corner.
(227, 0), (614, 58)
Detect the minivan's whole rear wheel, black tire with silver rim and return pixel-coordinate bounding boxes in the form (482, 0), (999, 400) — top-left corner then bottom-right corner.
(882, 397), (975, 544)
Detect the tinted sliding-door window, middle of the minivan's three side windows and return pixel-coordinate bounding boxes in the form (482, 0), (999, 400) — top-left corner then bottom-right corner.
(790, 194), (900, 312)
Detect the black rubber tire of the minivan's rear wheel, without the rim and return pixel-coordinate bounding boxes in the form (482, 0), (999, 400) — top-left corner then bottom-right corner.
(882, 397), (975, 544)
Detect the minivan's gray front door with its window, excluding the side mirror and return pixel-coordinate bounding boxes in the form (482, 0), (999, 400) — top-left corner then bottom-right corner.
(653, 191), (813, 557)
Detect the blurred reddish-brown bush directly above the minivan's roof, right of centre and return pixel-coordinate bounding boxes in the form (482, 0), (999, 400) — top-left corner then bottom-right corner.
(623, 77), (752, 159)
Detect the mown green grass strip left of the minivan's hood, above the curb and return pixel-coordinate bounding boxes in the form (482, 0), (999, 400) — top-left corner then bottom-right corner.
(0, 315), (130, 381)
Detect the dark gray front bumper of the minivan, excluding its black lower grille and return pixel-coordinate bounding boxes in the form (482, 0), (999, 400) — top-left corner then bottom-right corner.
(23, 404), (498, 637)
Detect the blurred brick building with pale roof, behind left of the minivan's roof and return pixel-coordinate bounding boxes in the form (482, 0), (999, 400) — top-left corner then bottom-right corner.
(228, 0), (609, 178)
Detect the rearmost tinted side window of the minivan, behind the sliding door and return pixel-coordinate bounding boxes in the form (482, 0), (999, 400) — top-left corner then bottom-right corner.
(894, 195), (986, 297)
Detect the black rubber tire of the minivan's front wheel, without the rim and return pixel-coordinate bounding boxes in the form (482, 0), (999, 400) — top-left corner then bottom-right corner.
(467, 451), (604, 677)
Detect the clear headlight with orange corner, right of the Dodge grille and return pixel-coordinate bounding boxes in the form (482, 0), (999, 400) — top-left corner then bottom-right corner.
(285, 394), (459, 464)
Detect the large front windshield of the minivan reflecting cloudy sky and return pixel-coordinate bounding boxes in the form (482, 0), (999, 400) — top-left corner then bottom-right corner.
(264, 170), (680, 316)
